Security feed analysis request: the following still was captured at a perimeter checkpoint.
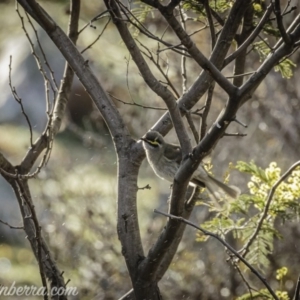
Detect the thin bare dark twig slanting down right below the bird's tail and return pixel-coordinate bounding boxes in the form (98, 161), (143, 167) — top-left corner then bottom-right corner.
(154, 209), (279, 300)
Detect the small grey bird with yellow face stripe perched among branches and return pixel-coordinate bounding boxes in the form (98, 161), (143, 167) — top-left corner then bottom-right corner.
(141, 131), (240, 198)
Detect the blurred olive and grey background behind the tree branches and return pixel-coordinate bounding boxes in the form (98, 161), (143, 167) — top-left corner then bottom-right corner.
(0, 0), (300, 299)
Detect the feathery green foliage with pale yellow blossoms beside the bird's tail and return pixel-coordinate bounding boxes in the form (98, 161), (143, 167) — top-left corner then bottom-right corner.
(198, 161), (300, 270)
